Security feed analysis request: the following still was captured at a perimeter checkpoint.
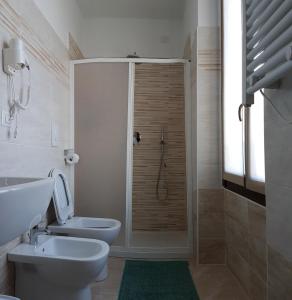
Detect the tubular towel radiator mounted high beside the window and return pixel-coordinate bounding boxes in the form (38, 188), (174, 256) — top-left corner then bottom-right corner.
(243, 0), (292, 97)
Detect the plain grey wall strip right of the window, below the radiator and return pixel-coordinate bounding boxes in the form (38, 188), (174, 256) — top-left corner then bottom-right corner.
(265, 72), (292, 262)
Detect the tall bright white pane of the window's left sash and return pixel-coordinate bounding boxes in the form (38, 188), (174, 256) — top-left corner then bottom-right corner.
(223, 0), (244, 176)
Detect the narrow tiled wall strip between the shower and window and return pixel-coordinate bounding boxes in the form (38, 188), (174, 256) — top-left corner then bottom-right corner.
(192, 27), (225, 263)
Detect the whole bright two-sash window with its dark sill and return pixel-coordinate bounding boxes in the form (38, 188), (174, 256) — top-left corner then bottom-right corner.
(222, 0), (265, 204)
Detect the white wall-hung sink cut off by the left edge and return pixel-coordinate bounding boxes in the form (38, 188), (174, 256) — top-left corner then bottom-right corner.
(0, 178), (54, 246)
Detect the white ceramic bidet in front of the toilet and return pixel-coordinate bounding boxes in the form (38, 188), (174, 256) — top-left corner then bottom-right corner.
(8, 236), (109, 300)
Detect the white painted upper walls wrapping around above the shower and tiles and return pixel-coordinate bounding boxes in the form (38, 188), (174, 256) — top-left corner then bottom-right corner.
(34, 0), (186, 58)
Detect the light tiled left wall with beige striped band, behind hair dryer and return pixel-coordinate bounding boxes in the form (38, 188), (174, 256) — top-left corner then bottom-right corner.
(0, 0), (73, 295)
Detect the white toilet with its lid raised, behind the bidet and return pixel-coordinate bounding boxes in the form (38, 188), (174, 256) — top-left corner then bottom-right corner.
(48, 169), (121, 281)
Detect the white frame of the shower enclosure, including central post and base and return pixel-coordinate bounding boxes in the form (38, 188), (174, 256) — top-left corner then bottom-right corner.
(70, 58), (195, 258)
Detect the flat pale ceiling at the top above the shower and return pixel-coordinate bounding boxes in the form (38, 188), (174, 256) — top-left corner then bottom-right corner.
(77, 0), (185, 19)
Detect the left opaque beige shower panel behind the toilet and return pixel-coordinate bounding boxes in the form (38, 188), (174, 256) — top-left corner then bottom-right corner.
(74, 63), (129, 246)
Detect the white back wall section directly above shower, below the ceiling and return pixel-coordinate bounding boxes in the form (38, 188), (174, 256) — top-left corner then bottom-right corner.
(79, 18), (182, 58)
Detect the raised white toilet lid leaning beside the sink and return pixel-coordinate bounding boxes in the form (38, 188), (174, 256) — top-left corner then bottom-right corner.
(49, 169), (74, 224)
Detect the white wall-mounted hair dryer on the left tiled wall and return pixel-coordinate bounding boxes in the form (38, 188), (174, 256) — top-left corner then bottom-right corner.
(3, 38), (29, 76)
